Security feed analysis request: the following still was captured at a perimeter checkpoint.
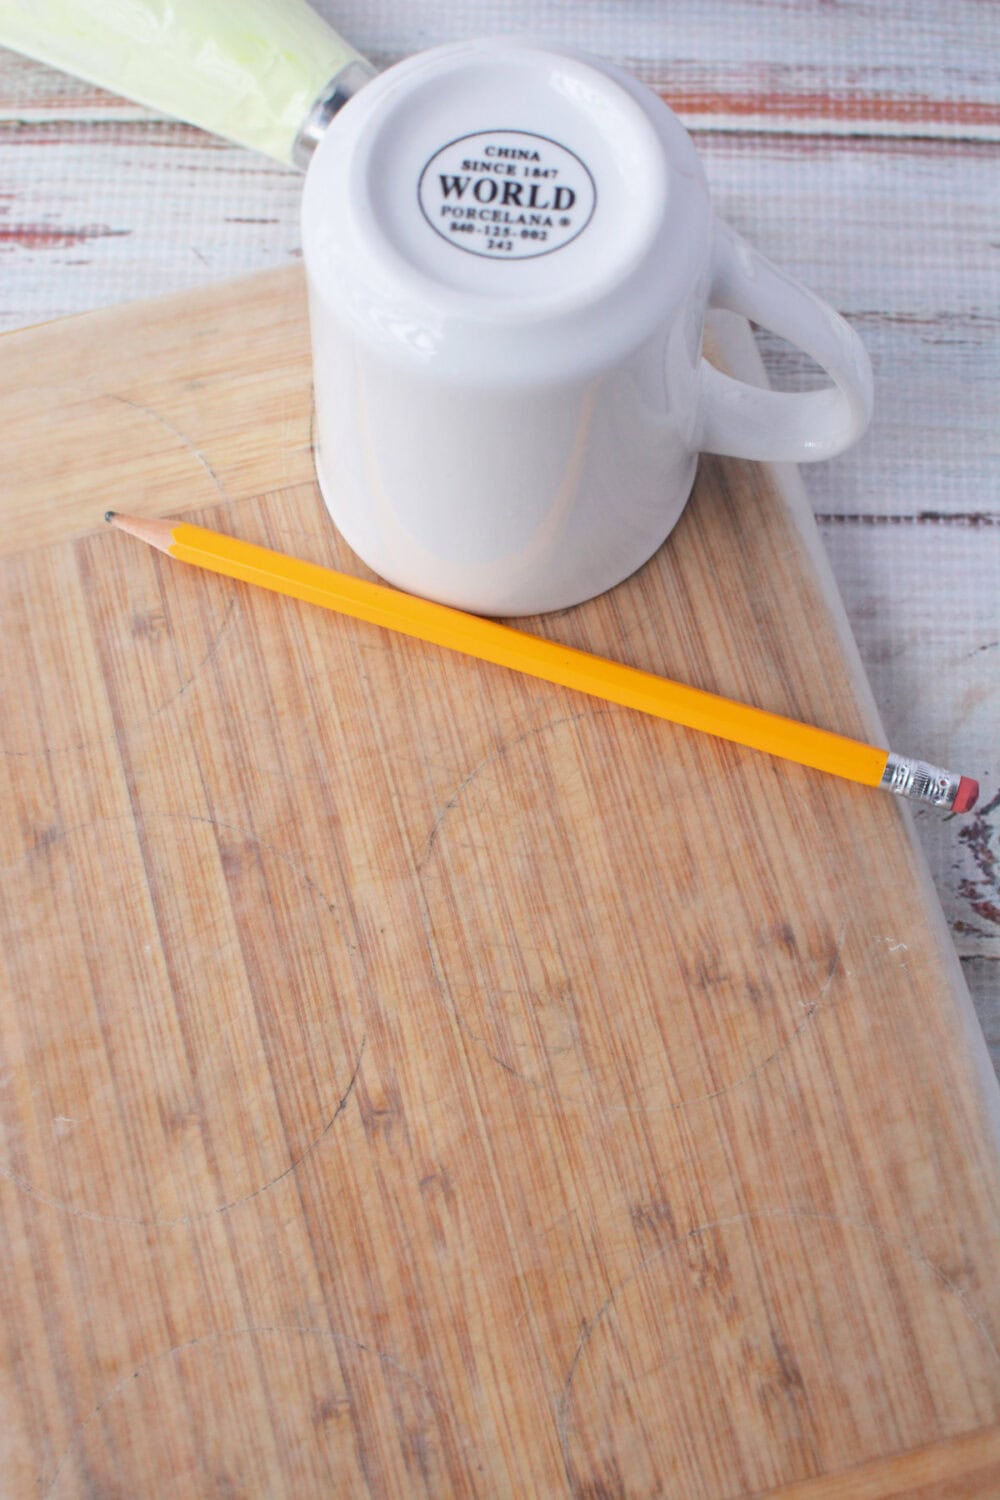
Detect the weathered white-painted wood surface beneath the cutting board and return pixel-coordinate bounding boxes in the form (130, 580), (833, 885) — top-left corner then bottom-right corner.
(0, 0), (1000, 1058)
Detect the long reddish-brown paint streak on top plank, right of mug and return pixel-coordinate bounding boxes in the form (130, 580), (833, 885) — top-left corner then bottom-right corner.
(655, 80), (1000, 128)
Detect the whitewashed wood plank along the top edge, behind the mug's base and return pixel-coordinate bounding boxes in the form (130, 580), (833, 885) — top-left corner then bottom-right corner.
(0, 0), (1000, 140)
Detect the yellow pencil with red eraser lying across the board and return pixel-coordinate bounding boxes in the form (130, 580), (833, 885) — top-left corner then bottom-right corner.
(105, 510), (979, 813)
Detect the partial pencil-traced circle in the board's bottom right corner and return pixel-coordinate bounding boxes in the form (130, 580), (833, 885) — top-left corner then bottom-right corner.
(558, 1209), (1000, 1500)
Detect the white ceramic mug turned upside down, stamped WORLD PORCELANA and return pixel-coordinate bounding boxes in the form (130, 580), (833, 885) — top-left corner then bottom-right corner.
(303, 41), (871, 615)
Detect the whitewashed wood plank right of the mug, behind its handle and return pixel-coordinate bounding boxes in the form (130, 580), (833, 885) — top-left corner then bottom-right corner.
(699, 137), (1000, 528)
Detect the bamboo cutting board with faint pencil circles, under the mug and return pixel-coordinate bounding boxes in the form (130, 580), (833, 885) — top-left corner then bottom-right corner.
(0, 273), (1000, 1500)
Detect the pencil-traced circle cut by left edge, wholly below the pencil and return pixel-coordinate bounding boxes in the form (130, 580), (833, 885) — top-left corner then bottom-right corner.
(0, 813), (366, 1224)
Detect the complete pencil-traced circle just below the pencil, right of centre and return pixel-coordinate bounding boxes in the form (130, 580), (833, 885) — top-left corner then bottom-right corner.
(420, 710), (847, 1112)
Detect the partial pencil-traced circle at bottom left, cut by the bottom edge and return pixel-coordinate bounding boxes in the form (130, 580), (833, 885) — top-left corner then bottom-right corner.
(43, 1326), (471, 1500)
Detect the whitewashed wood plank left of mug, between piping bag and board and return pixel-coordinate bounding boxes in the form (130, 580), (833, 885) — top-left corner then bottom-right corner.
(0, 123), (301, 327)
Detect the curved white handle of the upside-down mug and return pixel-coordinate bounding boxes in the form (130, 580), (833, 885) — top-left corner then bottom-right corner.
(694, 221), (873, 464)
